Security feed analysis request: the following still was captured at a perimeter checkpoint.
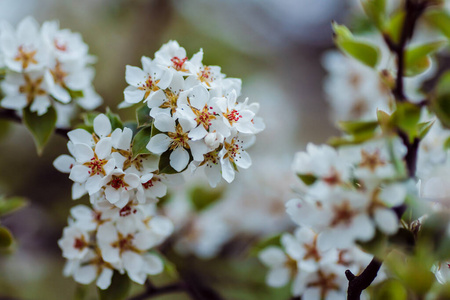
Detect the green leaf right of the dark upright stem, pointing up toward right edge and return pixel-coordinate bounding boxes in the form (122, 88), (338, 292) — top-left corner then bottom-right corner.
(405, 41), (447, 76)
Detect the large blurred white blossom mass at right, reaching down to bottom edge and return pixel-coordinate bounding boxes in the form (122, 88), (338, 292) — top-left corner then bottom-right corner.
(260, 139), (408, 299)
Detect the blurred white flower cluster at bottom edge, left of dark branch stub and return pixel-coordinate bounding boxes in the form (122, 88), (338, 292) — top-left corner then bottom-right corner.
(259, 227), (381, 300)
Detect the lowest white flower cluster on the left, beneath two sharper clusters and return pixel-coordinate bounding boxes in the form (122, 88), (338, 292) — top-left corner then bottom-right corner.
(58, 199), (173, 289)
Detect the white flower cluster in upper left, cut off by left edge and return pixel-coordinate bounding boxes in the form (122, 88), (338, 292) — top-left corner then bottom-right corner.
(0, 17), (102, 126)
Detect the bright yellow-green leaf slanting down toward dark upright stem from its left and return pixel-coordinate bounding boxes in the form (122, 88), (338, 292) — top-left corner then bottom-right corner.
(332, 22), (380, 68)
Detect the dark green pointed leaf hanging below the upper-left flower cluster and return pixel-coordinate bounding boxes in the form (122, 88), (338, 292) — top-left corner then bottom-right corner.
(23, 106), (57, 155)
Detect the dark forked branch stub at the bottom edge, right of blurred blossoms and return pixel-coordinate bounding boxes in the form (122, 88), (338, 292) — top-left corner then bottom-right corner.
(345, 258), (381, 300)
